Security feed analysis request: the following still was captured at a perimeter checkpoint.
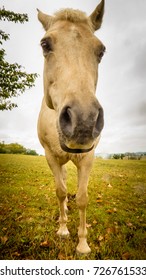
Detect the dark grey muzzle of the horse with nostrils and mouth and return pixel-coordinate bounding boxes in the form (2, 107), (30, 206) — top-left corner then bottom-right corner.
(58, 101), (104, 153)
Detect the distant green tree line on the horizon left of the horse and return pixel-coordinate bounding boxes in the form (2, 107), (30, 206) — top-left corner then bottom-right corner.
(0, 142), (38, 156)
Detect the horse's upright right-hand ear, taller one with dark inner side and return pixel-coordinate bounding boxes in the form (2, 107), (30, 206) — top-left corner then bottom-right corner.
(90, 0), (104, 31)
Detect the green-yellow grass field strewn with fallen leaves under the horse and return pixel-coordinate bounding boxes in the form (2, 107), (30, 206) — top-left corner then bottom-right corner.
(0, 155), (146, 260)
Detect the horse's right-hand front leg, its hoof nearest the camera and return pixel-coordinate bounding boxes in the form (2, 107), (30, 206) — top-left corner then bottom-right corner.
(76, 160), (91, 254)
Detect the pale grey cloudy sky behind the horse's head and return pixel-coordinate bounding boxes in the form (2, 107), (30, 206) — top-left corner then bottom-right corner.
(0, 0), (146, 153)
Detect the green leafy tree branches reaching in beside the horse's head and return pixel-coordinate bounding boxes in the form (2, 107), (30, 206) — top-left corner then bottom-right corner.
(0, 7), (37, 110)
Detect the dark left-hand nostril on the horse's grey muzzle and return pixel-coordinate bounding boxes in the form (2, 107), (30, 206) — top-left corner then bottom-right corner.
(59, 106), (72, 137)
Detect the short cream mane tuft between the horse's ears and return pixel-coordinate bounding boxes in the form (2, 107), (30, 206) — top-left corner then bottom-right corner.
(53, 9), (93, 29)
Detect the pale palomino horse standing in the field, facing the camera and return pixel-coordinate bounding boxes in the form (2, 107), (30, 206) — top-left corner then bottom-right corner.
(37, 0), (105, 254)
